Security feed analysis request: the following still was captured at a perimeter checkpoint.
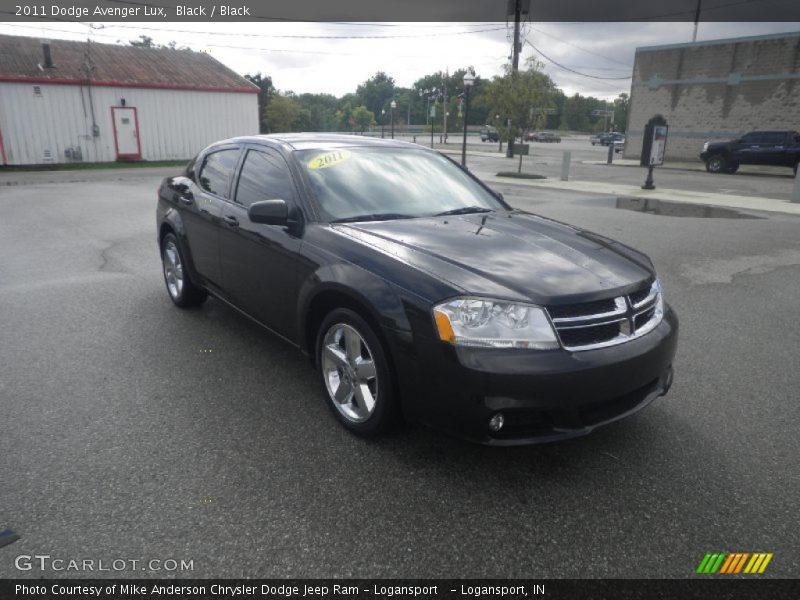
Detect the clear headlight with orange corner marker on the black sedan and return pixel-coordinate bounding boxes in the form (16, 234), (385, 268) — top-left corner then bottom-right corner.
(433, 298), (559, 350)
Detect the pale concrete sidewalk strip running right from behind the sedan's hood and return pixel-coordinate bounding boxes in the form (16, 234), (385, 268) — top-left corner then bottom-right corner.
(475, 172), (800, 216)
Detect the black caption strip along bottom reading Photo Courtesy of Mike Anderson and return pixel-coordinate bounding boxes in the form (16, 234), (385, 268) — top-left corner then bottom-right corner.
(0, 577), (800, 600)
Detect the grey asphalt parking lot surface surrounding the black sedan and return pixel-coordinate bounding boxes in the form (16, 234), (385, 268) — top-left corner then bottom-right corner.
(0, 158), (800, 578)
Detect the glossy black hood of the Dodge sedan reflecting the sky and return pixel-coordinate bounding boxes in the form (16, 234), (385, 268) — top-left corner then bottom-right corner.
(334, 211), (655, 304)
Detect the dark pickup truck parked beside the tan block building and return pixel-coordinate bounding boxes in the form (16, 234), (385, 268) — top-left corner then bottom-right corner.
(700, 129), (800, 174)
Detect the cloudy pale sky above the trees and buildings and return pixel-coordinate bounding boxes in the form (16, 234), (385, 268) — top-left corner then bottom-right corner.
(0, 22), (800, 99)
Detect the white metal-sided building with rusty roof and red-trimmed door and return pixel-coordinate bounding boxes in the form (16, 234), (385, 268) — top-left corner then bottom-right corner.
(0, 35), (259, 165)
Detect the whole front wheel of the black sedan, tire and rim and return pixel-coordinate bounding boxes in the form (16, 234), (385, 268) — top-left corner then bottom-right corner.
(316, 308), (398, 437)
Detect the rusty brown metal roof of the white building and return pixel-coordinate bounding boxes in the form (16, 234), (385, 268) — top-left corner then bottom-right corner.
(0, 35), (258, 93)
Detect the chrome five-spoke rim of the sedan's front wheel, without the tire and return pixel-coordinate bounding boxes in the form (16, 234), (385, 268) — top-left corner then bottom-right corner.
(322, 323), (378, 423)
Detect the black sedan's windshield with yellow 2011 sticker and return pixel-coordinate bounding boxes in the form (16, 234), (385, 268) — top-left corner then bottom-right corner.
(297, 147), (506, 221)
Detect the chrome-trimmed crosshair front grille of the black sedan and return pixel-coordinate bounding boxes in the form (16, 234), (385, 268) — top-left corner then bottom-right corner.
(547, 282), (663, 350)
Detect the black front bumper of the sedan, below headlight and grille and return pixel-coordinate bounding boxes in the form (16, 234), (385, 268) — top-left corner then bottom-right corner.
(396, 307), (678, 445)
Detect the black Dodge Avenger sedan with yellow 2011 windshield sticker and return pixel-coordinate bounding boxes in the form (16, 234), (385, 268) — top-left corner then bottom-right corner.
(157, 134), (678, 444)
